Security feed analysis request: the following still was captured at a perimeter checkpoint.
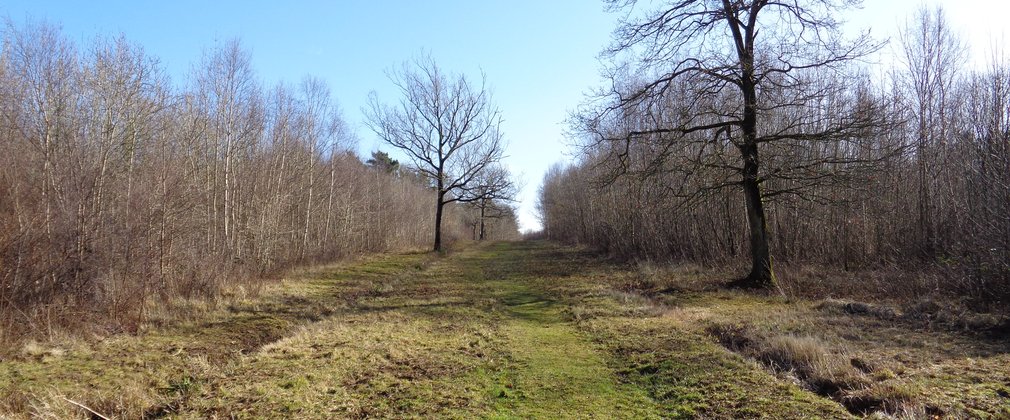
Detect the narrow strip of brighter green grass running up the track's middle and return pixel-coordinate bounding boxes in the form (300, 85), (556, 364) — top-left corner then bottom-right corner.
(471, 245), (660, 418)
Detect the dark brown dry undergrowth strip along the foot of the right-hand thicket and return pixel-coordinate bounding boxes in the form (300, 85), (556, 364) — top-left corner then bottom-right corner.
(626, 260), (1010, 336)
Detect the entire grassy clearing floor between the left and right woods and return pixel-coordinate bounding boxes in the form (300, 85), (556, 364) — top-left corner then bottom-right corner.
(0, 241), (1010, 418)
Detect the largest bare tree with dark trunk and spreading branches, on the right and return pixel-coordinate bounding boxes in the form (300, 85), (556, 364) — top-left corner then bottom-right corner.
(575, 0), (883, 288)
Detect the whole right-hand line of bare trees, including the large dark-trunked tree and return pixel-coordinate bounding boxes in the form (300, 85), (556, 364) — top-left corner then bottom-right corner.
(538, 0), (1010, 302)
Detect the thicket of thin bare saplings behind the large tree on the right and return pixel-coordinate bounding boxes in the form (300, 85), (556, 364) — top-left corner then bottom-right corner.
(538, 13), (1010, 316)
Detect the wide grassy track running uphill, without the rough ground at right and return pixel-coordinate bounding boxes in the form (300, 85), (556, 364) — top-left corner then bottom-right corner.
(0, 242), (848, 418)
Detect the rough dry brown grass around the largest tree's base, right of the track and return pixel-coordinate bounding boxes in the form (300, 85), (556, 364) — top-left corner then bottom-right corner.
(557, 246), (1010, 419)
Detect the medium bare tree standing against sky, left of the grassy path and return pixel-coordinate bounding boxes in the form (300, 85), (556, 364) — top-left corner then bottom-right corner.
(366, 57), (505, 250)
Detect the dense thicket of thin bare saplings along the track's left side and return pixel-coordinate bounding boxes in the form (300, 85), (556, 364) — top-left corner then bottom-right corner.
(0, 19), (516, 343)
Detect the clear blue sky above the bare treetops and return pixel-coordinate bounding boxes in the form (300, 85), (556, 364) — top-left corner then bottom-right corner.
(0, 0), (1010, 229)
